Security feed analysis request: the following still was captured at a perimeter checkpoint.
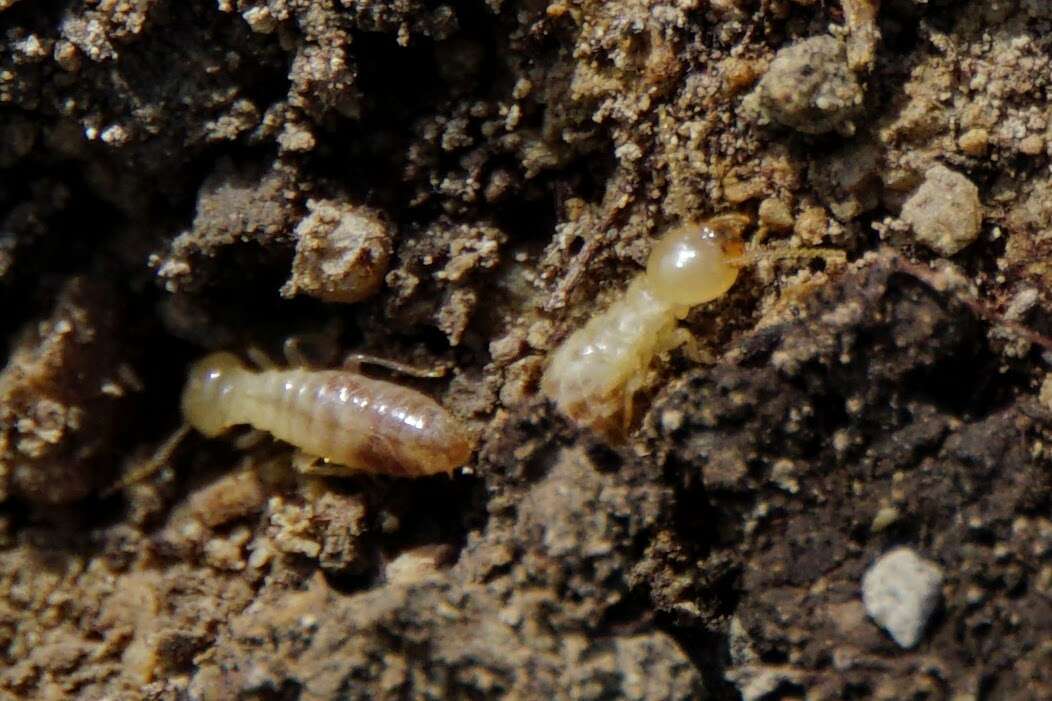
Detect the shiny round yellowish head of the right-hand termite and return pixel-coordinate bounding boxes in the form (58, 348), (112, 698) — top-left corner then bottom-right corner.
(647, 215), (749, 306)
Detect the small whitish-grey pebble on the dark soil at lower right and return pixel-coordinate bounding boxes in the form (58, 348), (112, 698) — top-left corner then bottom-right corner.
(862, 547), (943, 648)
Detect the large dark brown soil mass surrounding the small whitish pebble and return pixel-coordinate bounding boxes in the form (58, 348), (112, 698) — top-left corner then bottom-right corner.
(646, 255), (1052, 699)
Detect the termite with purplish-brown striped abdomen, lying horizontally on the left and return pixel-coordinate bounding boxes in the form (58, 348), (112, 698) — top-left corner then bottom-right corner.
(182, 353), (474, 477)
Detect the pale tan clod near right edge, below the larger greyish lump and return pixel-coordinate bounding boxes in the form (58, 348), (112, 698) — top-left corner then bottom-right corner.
(902, 165), (983, 257)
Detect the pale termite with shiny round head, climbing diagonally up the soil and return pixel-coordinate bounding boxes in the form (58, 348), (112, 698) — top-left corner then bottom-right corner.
(541, 214), (846, 437)
